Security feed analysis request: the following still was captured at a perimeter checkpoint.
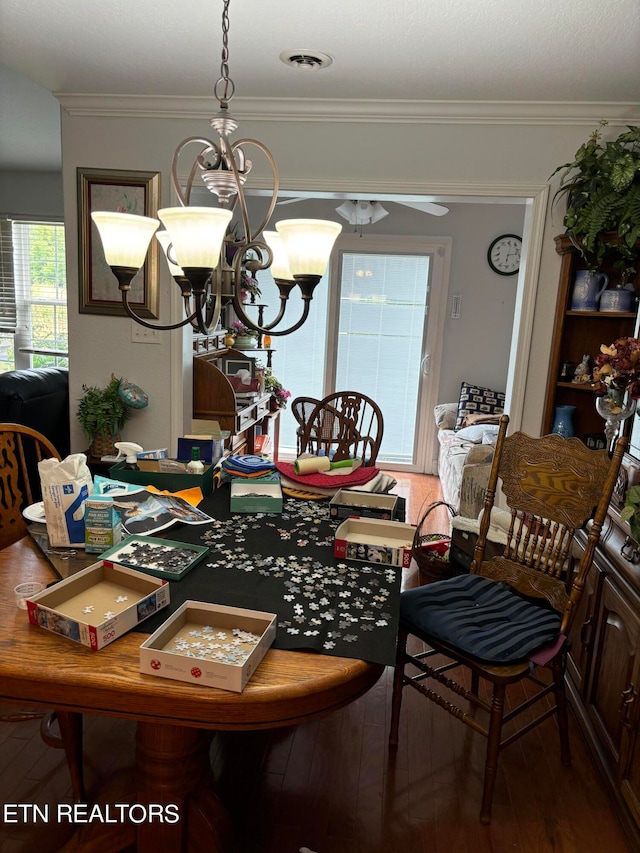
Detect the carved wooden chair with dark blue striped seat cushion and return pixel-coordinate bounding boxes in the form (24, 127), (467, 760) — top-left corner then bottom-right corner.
(389, 415), (627, 824)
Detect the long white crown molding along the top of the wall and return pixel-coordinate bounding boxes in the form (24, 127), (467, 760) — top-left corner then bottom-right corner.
(55, 92), (640, 126)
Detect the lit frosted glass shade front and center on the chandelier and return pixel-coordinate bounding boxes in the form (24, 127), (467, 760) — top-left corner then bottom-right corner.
(158, 207), (232, 269)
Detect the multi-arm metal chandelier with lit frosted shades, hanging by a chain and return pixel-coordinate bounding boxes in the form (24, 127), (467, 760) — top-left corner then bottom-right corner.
(91, 0), (342, 335)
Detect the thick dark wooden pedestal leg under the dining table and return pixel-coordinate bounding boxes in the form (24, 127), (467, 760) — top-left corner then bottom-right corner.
(136, 722), (233, 853)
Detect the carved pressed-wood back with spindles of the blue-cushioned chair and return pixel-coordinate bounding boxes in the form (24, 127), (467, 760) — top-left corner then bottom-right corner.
(471, 416), (627, 634)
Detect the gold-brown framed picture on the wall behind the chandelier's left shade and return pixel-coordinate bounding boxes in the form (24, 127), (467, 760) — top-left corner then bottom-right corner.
(77, 168), (160, 320)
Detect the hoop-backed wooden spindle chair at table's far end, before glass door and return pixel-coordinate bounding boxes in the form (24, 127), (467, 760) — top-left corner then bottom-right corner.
(300, 391), (384, 467)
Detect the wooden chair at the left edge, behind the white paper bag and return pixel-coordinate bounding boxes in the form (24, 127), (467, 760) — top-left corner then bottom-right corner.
(0, 423), (85, 802)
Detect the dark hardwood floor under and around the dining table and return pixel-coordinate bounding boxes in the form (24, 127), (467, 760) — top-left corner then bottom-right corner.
(0, 475), (632, 853)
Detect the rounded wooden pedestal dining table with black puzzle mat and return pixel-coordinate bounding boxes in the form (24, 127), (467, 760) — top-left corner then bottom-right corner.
(0, 490), (401, 853)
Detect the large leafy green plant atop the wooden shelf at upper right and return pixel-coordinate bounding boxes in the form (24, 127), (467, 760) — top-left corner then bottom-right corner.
(551, 121), (640, 285)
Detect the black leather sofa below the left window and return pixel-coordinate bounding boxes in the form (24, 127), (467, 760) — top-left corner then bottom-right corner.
(0, 367), (71, 459)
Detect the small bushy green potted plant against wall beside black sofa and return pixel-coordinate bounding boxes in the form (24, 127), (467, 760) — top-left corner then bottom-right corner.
(76, 375), (130, 457)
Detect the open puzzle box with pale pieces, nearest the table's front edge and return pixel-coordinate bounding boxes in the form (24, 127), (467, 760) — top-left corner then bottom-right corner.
(140, 601), (277, 693)
